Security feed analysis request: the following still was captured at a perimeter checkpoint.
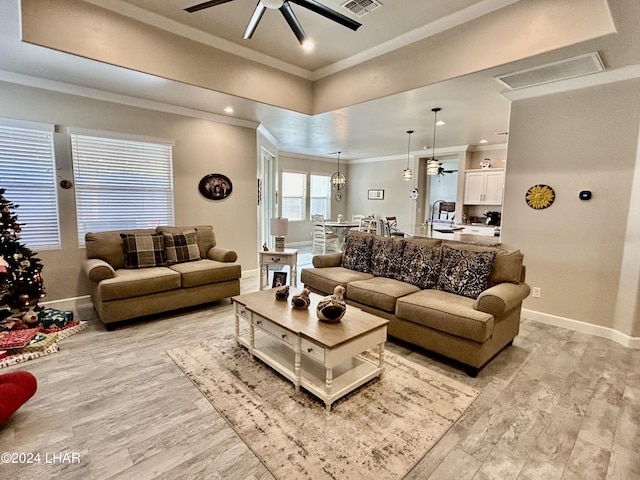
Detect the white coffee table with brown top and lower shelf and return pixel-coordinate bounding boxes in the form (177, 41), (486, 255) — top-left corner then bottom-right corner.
(231, 289), (389, 411)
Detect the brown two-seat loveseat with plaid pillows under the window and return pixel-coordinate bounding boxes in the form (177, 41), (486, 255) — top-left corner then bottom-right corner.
(84, 225), (241, 330)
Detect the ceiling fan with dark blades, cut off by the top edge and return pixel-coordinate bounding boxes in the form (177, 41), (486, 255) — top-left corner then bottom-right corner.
(185, 0), (361, 45)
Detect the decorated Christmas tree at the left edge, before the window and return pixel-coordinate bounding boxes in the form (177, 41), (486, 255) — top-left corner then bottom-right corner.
(0, 188), (44, 309)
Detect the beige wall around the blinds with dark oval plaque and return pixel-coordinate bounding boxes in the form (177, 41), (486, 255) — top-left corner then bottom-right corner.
(0, 82), (257, 301)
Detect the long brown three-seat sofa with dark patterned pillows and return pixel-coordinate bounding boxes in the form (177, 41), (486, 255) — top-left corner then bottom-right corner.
(301, 232), (530, 376)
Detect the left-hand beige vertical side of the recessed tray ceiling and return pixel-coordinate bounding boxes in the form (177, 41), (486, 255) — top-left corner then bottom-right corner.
(22, 0), (312, 113)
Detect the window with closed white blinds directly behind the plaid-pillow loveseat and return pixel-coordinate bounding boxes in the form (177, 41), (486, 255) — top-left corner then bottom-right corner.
(71, 131), (174, 245)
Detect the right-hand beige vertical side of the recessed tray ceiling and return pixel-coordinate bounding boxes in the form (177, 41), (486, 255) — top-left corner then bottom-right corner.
(313, 0), (612, 113)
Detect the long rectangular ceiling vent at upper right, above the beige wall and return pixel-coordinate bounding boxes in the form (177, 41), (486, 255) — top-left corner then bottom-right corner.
(493, 52), (604, 90)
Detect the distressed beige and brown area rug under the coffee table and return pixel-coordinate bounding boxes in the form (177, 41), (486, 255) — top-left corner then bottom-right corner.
(167, 335), (478, 480)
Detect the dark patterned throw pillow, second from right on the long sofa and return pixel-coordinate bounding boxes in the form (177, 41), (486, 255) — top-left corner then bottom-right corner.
(398, 243), (442, 290)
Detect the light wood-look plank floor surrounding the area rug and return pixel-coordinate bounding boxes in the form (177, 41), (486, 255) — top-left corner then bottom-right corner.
(0, 251), (640, 480)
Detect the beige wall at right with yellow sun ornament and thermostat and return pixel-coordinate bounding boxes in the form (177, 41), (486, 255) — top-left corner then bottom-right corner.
(502, 80), (640, 337)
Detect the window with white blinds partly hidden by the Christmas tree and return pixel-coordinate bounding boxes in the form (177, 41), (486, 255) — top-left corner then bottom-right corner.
(0, 119), (60, 248)
